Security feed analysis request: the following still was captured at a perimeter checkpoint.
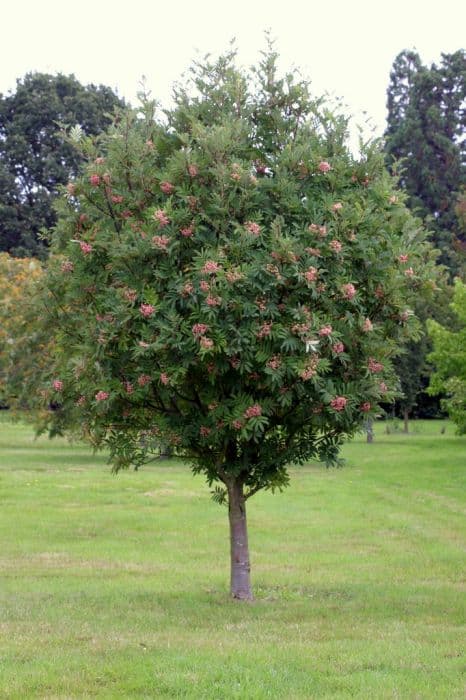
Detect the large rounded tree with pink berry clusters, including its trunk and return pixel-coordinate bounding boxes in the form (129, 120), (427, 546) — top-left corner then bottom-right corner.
(33, 49), (433, 599)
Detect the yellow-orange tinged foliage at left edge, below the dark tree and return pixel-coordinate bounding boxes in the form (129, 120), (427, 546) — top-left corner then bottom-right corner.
(0, 253), (45, 408)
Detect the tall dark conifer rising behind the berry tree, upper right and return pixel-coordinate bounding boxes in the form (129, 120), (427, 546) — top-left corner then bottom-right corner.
(385, 50), (466, 274)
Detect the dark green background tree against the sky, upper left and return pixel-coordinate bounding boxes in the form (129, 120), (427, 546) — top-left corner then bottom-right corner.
(0, 73), (123, 255)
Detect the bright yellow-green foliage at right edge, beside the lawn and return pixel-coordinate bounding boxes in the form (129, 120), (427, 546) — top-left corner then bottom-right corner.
(427, 279), (466, 435)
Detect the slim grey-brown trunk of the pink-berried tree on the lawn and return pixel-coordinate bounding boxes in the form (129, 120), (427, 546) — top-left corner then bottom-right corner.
(227, 478), (253, 600)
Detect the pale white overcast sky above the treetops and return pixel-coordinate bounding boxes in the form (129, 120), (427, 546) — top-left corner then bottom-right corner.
(0, 0), (466, 142)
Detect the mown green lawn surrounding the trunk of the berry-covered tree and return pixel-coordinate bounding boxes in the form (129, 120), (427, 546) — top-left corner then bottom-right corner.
(0, 416), (466, 700)
